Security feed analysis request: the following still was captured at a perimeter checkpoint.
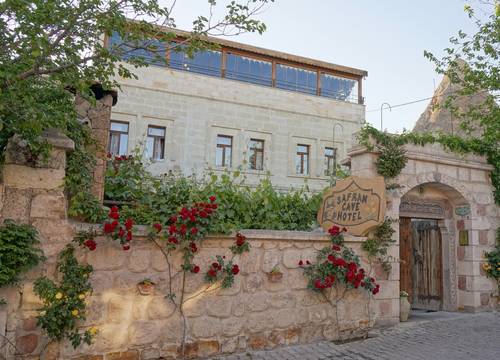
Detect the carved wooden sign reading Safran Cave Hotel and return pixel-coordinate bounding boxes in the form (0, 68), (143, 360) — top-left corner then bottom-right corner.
(318, 176), (386, 236)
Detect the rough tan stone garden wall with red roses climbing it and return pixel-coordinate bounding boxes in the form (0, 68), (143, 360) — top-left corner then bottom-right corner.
(0, 134), (390, 360)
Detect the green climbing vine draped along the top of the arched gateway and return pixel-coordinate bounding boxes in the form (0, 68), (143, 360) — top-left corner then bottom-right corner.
(358, 124), (500, 205)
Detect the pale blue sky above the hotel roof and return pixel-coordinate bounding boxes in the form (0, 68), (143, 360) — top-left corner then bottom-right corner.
(164, 0), (486, 132)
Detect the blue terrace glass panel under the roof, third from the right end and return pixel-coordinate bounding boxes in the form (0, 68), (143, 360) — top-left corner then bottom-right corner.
(226, 53), (273, 86)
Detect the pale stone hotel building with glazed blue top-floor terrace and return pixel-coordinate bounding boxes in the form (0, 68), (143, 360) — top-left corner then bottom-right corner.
(107, 33), (367, 190)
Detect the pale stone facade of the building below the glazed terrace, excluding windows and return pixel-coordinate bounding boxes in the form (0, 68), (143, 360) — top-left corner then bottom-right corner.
(111, 66), (365, 190)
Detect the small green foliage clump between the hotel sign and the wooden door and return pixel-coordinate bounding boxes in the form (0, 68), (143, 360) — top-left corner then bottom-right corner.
(361, 219), (395, 272)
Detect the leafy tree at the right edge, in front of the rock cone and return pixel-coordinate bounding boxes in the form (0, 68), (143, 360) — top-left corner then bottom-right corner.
(424, 0), (500, 203)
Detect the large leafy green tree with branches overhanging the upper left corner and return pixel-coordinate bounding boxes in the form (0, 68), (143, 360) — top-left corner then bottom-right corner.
(0, 0), (274, 157)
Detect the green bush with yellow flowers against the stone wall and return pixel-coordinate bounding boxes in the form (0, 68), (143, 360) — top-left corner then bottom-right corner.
(34, 245), (96, 348)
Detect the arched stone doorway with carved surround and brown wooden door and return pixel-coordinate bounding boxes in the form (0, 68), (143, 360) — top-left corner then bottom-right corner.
(399, 182), (469, 311)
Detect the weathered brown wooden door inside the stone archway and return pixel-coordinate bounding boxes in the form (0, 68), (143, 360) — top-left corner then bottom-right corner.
(399, 218), (443, 310)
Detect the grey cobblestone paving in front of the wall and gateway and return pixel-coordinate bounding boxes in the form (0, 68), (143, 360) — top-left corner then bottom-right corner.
(215, 312), (500, 360)
